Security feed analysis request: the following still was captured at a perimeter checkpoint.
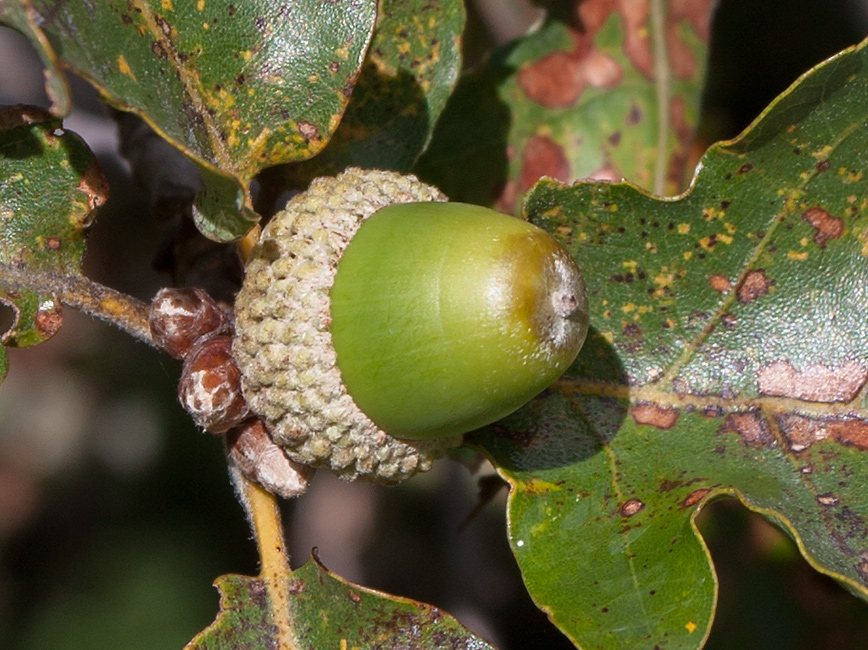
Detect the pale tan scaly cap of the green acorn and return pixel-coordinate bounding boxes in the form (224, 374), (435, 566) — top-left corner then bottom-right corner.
(233, 168), (461, 484)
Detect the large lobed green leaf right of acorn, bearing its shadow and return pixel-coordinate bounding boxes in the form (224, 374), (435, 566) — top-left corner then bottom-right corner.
(479, 36), (868, 650)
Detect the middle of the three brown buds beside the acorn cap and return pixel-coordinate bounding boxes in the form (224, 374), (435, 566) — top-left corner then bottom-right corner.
(178, 336), (248, 433)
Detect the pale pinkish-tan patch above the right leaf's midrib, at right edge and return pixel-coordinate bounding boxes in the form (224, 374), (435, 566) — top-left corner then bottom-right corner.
(757, 361), (868, 403)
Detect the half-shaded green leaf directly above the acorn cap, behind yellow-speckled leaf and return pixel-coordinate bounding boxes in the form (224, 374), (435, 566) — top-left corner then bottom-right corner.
(275, 0), (465, 187)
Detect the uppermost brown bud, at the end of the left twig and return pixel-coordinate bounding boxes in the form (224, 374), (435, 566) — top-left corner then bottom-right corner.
(148, 288), (229, 359)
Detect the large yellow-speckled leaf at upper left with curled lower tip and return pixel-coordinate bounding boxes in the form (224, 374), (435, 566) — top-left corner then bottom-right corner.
(7, 0), (376, 240)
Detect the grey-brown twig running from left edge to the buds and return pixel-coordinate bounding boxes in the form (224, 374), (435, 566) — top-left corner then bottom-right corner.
(0, 264), (154, 345)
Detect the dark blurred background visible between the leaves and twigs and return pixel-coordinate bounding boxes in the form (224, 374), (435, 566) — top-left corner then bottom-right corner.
(0, 0), (868, 650)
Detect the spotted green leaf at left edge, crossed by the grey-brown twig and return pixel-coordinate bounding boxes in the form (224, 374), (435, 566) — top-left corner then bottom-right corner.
(0, 106), (108, 364)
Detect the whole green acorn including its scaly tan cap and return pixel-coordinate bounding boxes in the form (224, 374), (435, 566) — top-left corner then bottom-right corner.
(233, 168), (588, 484)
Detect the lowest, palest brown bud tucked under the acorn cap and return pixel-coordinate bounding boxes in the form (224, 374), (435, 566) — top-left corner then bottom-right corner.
(226, 420), (315, 499)
